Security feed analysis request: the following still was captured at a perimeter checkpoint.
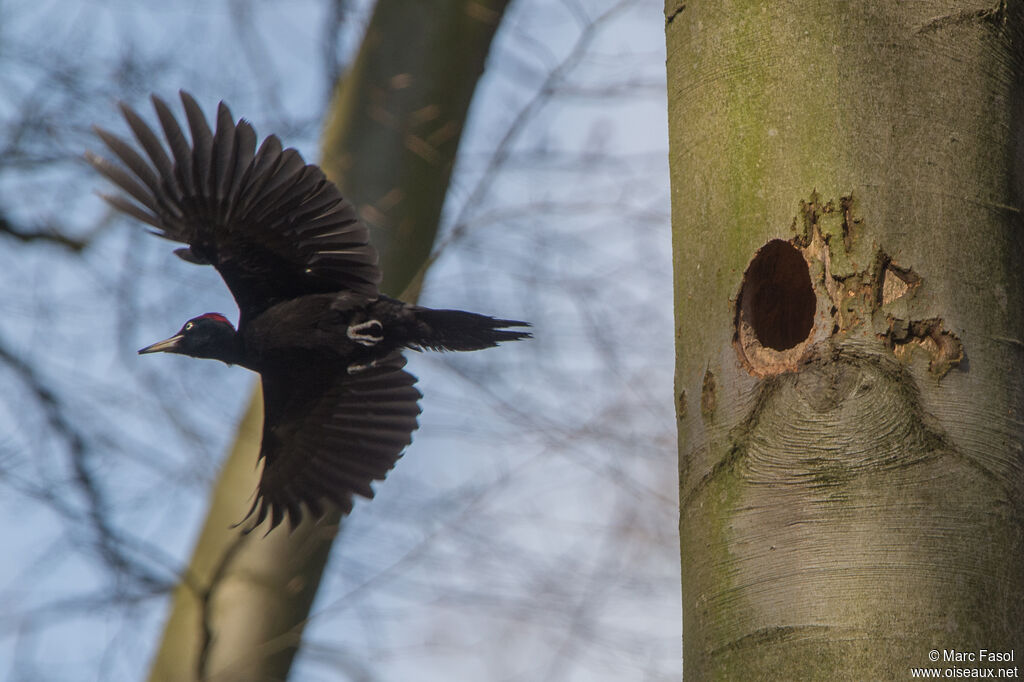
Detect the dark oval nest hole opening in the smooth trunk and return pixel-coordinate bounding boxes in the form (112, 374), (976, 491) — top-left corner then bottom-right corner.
(739, 240), (816, 350)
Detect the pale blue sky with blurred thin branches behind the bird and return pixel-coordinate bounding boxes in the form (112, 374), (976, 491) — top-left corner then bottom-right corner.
(0, 0), (680, 680)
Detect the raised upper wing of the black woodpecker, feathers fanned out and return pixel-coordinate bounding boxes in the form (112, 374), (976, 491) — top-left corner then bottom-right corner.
(86, 91), (381, 326)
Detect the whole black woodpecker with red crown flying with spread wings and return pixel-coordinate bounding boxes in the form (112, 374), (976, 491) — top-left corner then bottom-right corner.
(87, 92), (529, 528)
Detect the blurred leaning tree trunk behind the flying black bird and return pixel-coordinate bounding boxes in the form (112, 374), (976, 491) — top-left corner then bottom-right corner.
(150, 0), (507, 682)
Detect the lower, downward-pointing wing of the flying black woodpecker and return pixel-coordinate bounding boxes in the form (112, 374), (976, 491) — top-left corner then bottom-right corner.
(247, 353), (421, 529)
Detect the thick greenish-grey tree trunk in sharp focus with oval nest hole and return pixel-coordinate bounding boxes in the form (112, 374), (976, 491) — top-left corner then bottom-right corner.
(666, 0), (1024, 680)
